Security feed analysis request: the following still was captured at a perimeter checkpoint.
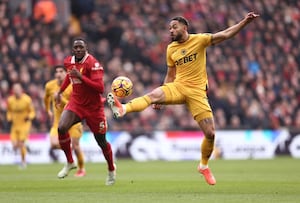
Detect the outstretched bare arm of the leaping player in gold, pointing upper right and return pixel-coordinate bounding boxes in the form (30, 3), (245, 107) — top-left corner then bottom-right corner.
(212, 12), (259, 45)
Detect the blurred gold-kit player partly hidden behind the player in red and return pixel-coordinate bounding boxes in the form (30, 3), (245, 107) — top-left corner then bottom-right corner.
(44, 65), (86, 177)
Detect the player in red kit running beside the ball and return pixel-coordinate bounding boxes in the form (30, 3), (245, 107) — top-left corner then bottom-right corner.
(56, 39), (116, 185)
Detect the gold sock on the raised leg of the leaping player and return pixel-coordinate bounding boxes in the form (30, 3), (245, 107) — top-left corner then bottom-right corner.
(125, 95), (151, 113)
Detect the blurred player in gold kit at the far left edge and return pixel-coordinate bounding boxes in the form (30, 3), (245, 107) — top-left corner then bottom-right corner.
(6, 83), (35, 169)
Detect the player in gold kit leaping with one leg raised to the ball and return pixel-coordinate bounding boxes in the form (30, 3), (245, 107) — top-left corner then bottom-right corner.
(107, 12), (259, 185)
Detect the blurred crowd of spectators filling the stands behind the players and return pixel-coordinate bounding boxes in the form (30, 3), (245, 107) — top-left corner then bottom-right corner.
(0, 0), (300, 132)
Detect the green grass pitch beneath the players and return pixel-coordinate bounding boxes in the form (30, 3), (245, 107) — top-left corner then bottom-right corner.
(0, 157), (300, 203)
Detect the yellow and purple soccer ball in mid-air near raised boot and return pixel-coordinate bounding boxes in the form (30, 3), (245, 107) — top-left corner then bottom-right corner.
(111, 76), (133, 98)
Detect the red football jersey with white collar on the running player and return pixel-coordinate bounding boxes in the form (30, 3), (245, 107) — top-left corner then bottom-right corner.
(61, 54), (104, 109)
